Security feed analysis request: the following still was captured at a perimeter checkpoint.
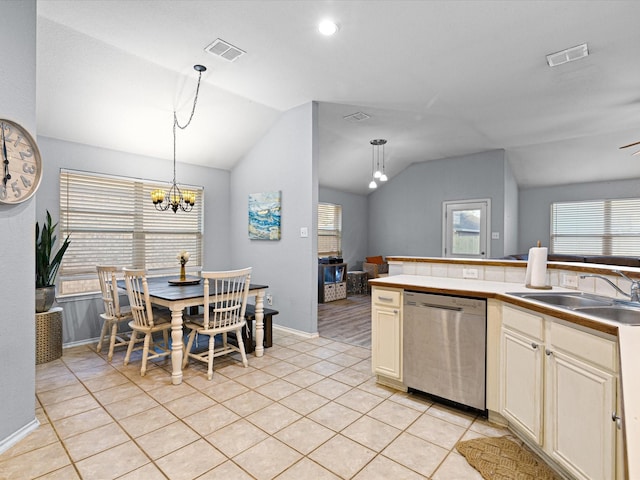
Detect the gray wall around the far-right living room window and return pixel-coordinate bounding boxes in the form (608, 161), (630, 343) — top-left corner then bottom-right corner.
(524, 178), (640, 253)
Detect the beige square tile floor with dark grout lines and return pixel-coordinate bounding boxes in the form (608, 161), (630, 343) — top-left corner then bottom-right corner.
(0, 330), (507, 480)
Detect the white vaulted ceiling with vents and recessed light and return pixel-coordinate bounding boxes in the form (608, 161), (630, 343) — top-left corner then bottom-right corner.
(37, 0), (640, 194)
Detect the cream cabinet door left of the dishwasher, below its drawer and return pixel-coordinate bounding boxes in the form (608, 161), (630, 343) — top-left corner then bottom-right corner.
(371, 306), (402, 381)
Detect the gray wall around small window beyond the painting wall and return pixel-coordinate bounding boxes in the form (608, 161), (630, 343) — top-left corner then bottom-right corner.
(318, 187), (374, 270)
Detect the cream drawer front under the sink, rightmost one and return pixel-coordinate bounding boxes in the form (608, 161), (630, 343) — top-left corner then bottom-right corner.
(550, 322), (618, 372)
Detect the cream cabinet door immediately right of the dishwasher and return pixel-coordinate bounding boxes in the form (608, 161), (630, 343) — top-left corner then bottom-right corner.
(500, 327), (544, 445)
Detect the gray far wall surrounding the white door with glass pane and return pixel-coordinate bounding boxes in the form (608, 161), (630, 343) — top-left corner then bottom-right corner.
(368, 150), (517, 258)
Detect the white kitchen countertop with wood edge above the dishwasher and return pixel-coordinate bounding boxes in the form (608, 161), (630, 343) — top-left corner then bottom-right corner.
(369, 275), (640, 479)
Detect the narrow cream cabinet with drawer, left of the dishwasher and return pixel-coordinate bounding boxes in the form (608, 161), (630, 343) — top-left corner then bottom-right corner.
(371, 286), (402, 386)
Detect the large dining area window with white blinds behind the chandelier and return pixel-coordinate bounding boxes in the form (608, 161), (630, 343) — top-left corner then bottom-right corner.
(58, 170), (204, 295)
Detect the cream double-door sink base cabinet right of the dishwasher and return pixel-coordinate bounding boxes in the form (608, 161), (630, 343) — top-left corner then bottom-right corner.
(499, 305), (622, 479)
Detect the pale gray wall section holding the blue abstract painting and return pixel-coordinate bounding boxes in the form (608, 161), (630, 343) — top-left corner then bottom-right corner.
(230, 103), (318, 334)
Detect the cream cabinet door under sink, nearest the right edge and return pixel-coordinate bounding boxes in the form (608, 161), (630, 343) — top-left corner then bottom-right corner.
(545, 350), (616, 479)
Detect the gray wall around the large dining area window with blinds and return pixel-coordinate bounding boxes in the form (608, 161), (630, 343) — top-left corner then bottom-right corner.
(37, 137), (231, 344)
